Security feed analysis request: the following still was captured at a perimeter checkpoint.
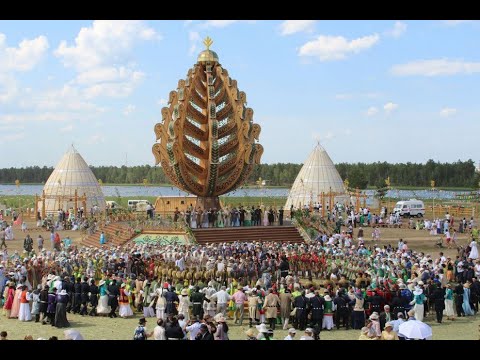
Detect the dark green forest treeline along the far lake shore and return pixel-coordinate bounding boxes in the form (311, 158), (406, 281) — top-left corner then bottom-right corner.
(0, 160), (480, 189)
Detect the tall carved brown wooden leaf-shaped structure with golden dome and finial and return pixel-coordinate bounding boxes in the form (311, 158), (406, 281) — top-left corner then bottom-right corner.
(152, 38), (263, 206)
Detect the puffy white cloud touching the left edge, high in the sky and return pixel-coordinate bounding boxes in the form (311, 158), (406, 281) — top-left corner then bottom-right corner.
(0, 33), (48, 72)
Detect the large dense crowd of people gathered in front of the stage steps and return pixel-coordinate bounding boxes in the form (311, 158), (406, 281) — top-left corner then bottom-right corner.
(0, 214), (480, 340)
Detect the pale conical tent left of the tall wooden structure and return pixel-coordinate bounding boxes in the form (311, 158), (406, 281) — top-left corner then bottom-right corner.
(39, 146), (106, 214)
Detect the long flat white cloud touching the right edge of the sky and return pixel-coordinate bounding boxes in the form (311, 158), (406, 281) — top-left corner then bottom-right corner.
(390, 59), (480, 76)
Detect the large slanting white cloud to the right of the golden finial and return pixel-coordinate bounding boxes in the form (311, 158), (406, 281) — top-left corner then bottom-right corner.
(298, 34), (380, 61)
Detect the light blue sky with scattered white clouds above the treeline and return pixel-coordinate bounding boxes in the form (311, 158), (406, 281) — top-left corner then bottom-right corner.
(0, 20), (480, 168)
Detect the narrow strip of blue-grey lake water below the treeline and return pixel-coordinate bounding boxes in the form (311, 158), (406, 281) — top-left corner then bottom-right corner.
(0, 185), (470, 200)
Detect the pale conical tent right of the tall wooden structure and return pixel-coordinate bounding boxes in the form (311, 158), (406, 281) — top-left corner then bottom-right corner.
(285, 144), (348, 210)
